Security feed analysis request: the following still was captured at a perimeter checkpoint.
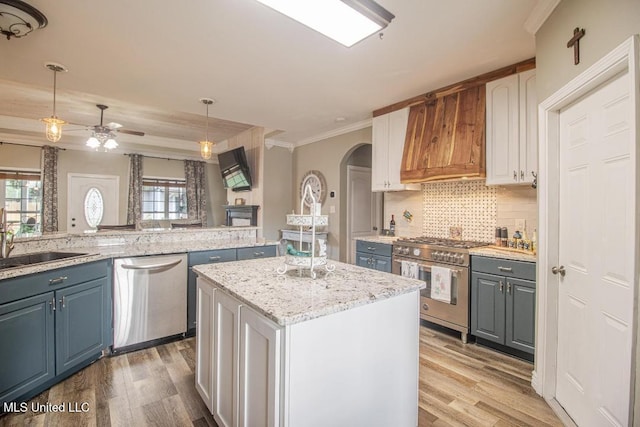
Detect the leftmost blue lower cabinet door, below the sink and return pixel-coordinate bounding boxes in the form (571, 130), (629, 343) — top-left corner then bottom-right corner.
(0, 292), (55, 404)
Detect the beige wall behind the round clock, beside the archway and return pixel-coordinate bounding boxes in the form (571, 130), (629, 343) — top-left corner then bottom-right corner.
(292, 127), (371, 259)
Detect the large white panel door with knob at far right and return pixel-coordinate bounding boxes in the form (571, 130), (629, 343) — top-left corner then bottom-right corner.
(556, 68), (636, 427)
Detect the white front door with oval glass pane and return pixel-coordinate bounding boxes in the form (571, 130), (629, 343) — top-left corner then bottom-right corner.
(67, 173), (120, 233)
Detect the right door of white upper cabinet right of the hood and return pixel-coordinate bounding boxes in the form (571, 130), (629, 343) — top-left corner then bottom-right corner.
(518, 70), (538, 183)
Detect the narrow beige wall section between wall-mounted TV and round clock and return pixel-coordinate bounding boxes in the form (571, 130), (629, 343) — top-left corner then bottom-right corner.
(262, 147), (293, 240)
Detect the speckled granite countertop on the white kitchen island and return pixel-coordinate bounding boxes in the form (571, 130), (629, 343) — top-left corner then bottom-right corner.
(193, 257), (426, 326)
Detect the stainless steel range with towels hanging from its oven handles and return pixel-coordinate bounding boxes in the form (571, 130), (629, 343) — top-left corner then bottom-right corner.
(391, 237), (489, 343)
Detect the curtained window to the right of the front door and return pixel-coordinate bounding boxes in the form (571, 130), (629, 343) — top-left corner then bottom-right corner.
(142, 178), (187, 220)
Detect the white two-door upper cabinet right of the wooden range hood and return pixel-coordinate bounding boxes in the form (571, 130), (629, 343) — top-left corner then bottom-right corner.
(486, 70), (538, 185)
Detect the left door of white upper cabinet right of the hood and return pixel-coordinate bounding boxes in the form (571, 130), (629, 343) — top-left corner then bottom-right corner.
(486, 74), (520, 185)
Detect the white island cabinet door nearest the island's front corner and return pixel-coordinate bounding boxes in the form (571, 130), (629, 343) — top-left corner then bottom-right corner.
(238, 306), (282, 427)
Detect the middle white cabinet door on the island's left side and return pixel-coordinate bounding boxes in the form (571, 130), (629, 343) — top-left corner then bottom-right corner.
(212, 291), (242, 427)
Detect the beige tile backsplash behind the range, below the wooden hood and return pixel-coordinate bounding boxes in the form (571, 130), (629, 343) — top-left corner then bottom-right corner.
(384, 180), (538, 242)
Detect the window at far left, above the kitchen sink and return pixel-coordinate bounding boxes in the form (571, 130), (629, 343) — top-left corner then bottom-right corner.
(0, 171), (42, 236)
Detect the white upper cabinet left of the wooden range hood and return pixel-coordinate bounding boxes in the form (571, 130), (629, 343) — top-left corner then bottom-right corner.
(371, 107), (420, 191)
